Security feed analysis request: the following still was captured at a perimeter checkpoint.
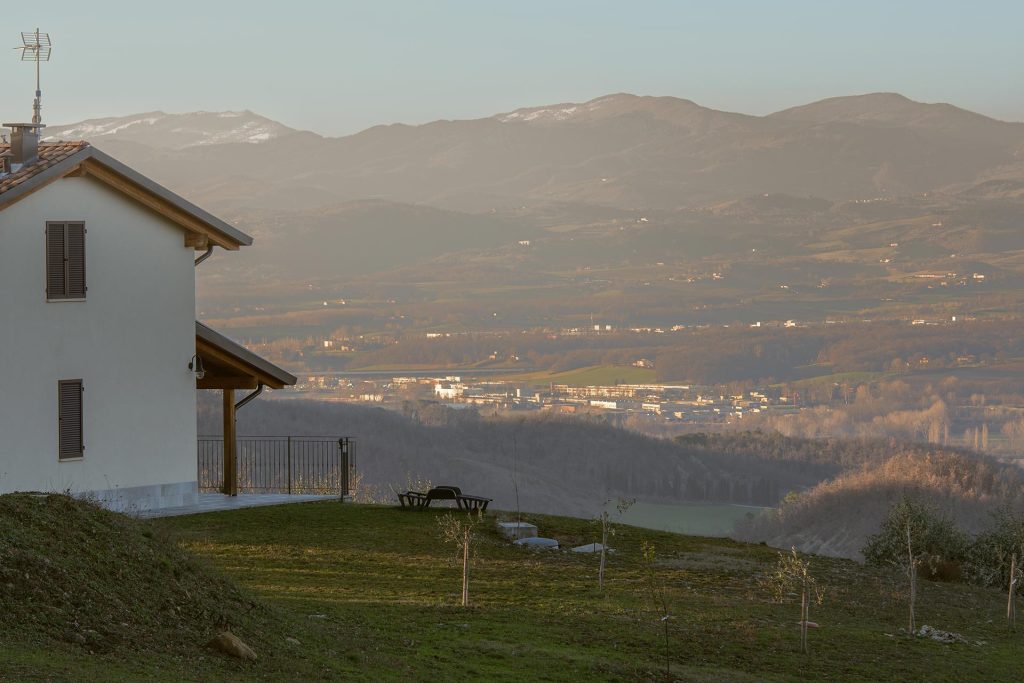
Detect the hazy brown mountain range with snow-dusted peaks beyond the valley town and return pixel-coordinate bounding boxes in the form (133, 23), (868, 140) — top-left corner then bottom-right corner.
(29, 93), (1024, 337)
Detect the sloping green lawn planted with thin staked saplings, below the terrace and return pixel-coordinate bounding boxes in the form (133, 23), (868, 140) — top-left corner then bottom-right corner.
(0, 503), (1024, 681)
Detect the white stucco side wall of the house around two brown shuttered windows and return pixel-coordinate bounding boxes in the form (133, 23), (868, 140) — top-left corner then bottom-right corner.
(0, 178), (196, 508)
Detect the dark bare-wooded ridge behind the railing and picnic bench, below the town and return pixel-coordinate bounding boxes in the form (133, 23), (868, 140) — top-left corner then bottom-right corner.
(200, 400), (1003, 516)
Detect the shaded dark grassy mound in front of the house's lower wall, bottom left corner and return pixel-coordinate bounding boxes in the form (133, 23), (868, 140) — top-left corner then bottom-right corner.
(0, 494), (335, 681)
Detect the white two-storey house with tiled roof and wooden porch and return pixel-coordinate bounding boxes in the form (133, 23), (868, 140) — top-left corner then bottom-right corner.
(0, 124), (295, 510)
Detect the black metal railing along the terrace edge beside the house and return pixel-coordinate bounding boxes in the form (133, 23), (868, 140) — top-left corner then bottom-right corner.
(199, 436), (355, 496)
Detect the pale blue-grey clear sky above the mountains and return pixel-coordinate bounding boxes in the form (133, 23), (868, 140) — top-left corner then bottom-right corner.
(0, 0), (1024, 135)
